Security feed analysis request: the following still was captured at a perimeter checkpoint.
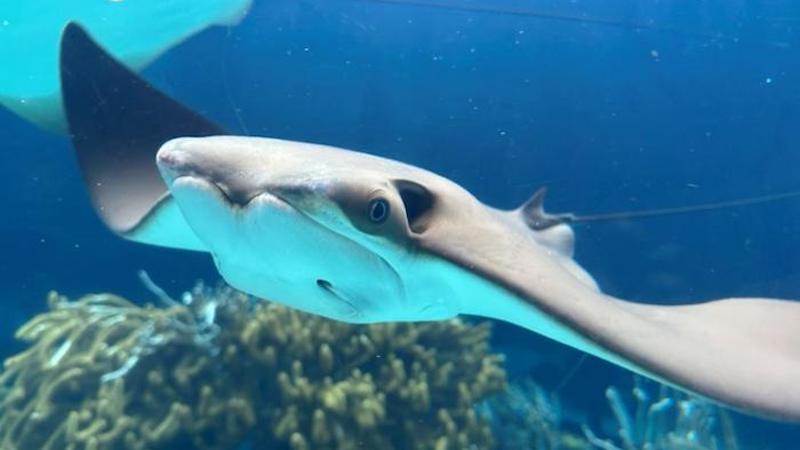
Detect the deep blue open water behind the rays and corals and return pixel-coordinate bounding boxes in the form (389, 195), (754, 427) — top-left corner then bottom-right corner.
(0, 0), (800, 448)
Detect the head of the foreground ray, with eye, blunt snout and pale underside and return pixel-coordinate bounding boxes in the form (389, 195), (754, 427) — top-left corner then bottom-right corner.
(157, 136), (466, 322)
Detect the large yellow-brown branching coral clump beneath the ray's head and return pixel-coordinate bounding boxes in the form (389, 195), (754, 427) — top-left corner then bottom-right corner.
(0, 287), (505, 450)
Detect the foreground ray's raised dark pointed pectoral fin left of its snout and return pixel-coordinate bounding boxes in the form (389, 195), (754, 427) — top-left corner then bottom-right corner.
(60, 23), (224, 250)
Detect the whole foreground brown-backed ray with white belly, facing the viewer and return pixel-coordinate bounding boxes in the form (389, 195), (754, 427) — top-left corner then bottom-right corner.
(61, 25), (800, 421)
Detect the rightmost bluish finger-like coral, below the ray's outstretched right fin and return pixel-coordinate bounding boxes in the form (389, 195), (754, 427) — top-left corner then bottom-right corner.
(583, 377), (739, 450)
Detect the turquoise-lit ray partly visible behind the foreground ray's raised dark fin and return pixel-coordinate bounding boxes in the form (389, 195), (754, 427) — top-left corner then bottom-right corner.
(0, 0), (252, 131)
